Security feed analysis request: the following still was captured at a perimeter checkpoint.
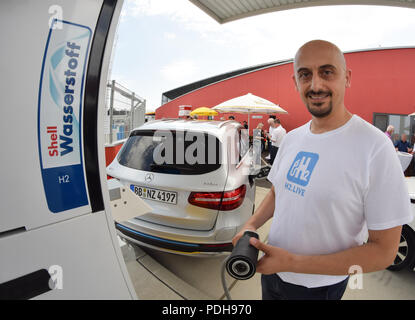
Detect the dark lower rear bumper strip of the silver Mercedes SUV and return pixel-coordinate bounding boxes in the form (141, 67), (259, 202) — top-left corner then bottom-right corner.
(115, 223), (233, 254)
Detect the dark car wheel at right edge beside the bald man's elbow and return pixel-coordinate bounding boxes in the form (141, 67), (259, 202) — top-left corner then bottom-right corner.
(387, 225), (415, 271)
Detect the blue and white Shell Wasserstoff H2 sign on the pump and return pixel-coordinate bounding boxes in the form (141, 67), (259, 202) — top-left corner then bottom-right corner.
(38, 19), (92, 213)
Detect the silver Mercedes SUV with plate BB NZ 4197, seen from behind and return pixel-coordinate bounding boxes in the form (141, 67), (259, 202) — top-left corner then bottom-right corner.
(107, 119), (255, 254)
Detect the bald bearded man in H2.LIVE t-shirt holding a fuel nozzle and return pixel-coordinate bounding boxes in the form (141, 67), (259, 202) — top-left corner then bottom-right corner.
(233, 40), (412, 299)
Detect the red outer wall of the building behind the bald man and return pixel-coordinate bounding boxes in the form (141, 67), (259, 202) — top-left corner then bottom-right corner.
(156, 48), (415, 131)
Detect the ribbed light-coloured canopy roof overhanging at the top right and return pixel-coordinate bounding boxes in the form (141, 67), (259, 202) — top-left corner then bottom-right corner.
(189, 0), (415, 23)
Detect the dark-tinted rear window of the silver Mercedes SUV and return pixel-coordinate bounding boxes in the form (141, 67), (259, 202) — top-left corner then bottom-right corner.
(118, 130), (221, 175)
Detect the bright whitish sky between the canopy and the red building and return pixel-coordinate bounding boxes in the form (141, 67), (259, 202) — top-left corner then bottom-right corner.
(110, 0), (415, 111)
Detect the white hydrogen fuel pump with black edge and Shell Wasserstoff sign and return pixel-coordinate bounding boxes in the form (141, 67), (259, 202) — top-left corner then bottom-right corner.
(0, 0), (137, 299)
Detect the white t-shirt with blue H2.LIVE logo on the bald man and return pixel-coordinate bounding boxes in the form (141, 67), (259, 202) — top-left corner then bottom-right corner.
(268, 115), (412, 288)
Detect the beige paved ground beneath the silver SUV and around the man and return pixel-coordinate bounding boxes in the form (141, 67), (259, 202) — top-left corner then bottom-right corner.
(122, 179), (415, 300)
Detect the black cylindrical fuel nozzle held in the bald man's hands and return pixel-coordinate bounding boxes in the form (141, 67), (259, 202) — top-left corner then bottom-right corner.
(226, 231), (259, 280)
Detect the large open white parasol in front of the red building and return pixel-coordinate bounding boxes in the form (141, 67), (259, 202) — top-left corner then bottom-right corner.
(212, 93), (288, 128)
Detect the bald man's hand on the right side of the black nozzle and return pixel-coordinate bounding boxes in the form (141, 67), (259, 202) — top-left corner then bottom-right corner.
(249, 238), (293, 274)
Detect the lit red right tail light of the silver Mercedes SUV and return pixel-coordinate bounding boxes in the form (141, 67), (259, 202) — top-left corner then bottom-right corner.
(188, 185), (246, 211)
